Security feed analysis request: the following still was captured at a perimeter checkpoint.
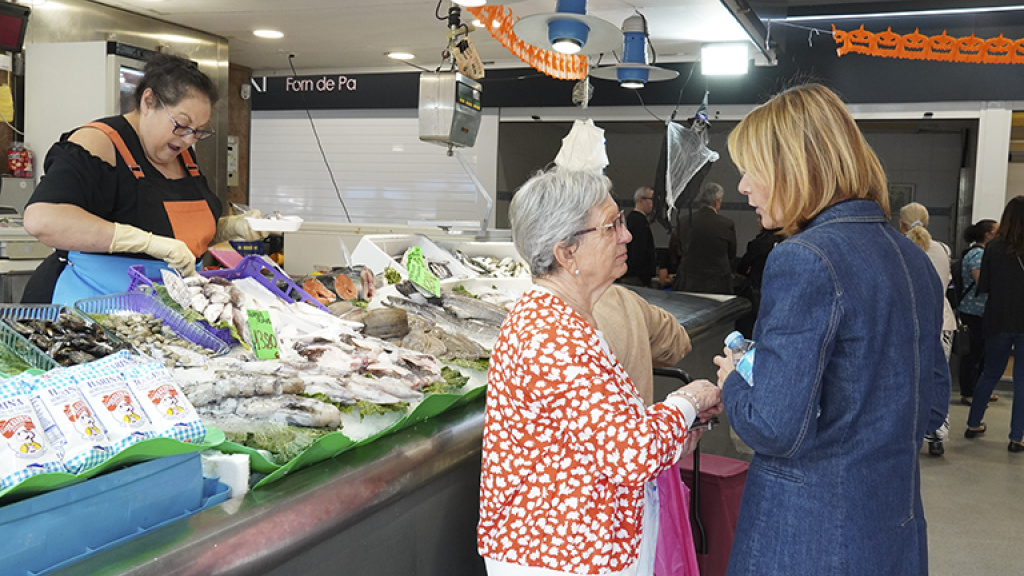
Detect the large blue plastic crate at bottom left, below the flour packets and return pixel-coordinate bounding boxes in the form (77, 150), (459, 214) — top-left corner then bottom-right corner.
(0, 452), (227, 575)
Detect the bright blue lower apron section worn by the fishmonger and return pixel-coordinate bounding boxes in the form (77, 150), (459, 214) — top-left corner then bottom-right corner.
(51, 252), (197, 306)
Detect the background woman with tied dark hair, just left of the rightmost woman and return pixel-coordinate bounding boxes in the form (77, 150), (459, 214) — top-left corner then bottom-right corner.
(956, 219), (999, 406)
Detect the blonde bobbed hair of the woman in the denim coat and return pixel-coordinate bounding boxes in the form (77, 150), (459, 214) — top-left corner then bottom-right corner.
(729, 84), (889, 236)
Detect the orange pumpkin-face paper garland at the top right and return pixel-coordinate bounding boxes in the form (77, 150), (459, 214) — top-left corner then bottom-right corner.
(833, 25), (1024, 64)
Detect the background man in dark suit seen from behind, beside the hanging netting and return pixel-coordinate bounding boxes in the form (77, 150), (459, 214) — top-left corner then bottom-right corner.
(672, 182), (736, 294)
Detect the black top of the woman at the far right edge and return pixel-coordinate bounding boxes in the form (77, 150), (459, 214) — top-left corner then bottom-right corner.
(978, 237), (1024, 337)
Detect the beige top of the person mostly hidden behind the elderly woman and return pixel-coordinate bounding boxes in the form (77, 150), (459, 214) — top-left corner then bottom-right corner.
(594, 284), (691, 406)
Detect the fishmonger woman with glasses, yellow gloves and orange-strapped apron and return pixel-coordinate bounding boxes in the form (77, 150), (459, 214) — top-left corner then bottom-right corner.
(23, 54), (258, 304)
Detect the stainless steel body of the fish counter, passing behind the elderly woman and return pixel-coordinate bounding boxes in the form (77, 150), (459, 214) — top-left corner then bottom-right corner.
(44, 288), (750, 576)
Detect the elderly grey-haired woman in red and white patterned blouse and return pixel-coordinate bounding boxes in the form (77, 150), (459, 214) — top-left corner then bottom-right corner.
(477, 168), (721, 576)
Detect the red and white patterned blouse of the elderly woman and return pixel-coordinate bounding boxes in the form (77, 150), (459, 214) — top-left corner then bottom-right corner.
(477, 287), (687, 574)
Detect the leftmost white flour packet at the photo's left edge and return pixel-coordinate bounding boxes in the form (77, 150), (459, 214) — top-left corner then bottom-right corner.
(0, 381), (67, 488)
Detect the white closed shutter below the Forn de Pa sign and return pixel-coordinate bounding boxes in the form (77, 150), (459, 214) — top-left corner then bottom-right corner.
(250, 110), (498, 224)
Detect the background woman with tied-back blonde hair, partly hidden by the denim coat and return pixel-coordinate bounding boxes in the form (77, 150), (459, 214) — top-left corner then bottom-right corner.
(899, 202), (956, 456)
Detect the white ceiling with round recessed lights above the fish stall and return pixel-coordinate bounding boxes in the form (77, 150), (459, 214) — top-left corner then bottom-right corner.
(83, 0), (746, 74)
